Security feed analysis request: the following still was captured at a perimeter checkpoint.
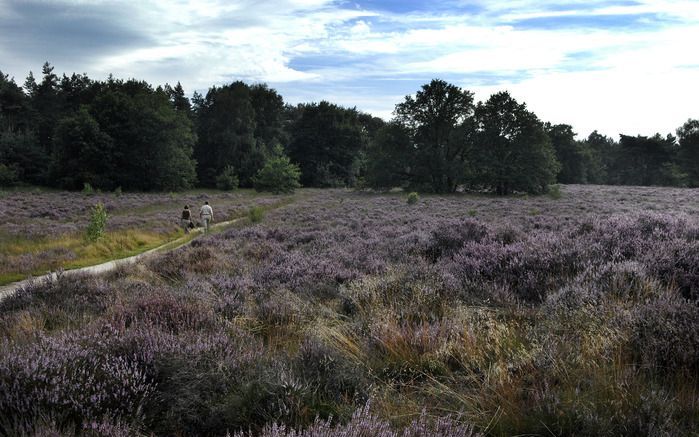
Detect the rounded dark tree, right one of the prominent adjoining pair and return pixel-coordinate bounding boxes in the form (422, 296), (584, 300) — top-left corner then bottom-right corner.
(473, 92), (560, 195)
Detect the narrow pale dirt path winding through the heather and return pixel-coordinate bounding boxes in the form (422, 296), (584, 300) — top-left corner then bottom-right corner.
(0, 217), (243, 301)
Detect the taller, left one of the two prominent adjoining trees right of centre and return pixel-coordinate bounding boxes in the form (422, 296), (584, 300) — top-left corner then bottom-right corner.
(395, 79), (474, 192)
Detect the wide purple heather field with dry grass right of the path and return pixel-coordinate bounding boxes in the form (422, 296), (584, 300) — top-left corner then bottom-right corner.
(0, 186), (699, 437)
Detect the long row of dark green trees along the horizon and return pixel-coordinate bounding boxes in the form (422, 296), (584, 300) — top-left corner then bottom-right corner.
(0, 63), (699, 194)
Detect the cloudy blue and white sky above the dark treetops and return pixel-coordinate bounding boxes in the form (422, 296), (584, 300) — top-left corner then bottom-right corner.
(0, 0), (699, 138)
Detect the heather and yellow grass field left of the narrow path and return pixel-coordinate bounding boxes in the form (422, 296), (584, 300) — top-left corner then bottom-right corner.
(0, 191), (285, 285)
